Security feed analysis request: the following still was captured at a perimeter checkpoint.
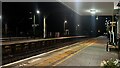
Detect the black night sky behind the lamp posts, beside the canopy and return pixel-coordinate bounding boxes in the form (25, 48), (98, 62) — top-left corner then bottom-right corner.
(2, 2), (111, 36)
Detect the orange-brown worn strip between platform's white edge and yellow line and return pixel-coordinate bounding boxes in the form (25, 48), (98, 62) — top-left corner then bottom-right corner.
(1, 39), (94, 68)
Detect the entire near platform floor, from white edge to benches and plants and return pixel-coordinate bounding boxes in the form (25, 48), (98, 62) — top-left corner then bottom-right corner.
(0, 36), (118, 68)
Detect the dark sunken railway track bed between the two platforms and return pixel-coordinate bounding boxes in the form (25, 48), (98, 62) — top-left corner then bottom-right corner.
(2, 38), (88, 65)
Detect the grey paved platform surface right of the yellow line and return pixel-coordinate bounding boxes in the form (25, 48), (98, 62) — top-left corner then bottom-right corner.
(56, 36), (118, 66)
